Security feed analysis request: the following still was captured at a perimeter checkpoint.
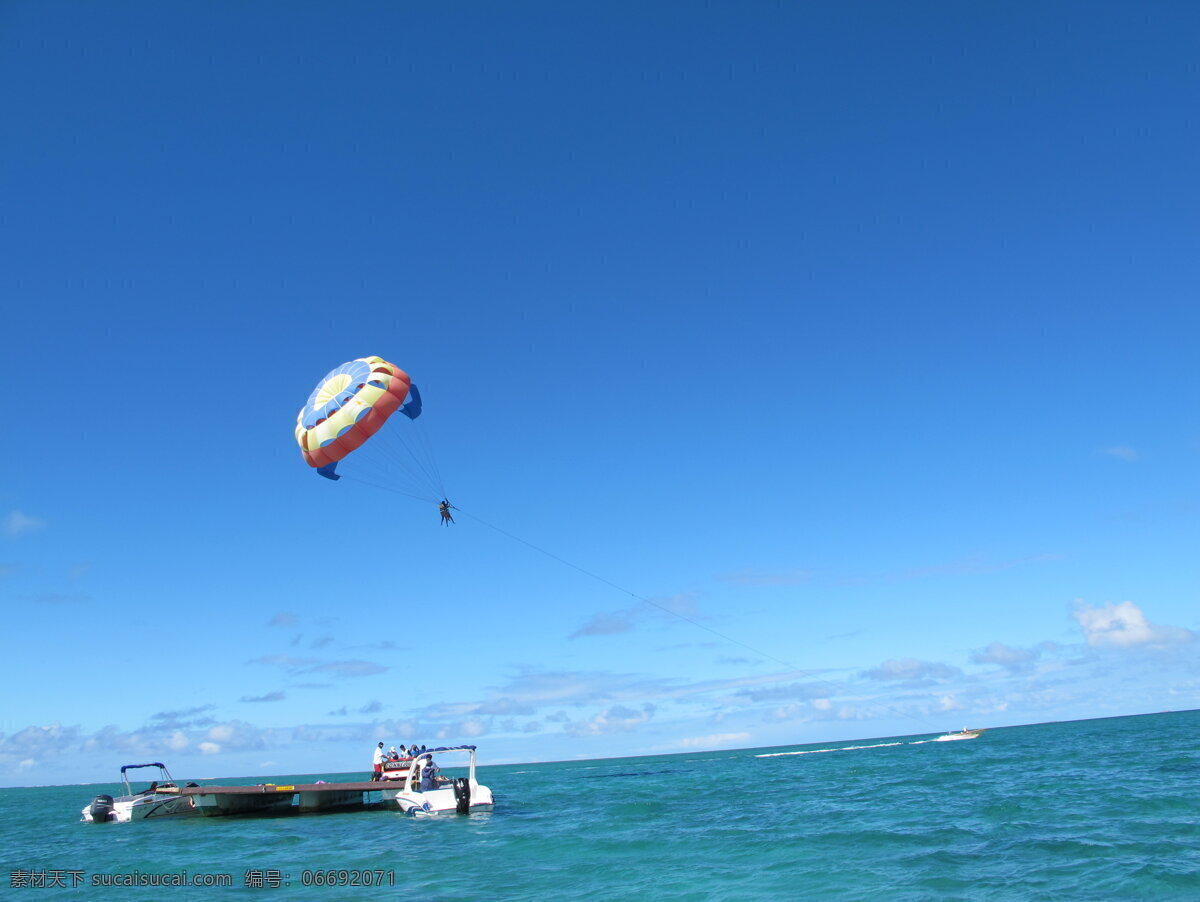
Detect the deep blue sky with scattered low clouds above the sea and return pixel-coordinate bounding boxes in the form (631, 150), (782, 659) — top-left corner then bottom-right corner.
(0, 2), (1200, 784)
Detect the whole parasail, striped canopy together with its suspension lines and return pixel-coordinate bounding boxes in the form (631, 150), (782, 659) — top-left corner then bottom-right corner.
(295, 357), (445, 500)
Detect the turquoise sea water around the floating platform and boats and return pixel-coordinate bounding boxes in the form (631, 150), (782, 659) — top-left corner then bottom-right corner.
(0, 711), (1200, 900)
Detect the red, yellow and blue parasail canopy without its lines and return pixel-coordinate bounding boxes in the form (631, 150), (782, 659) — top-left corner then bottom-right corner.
(295, 357), (421, 479)
